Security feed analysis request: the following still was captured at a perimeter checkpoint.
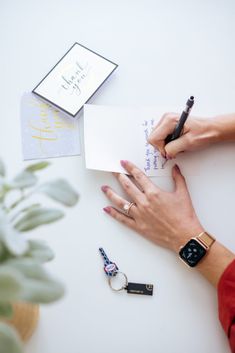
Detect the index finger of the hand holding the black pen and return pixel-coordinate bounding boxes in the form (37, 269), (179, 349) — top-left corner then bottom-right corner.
(148, 113), (179, 157)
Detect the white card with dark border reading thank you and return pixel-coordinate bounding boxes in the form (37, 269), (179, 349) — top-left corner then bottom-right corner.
(33, 43), (117, 117)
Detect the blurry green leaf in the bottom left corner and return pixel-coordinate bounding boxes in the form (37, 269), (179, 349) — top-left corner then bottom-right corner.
(0, 322), (24, 353)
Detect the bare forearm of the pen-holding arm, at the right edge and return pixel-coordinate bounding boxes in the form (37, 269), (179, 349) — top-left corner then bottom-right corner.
(208, 114), (235, 143)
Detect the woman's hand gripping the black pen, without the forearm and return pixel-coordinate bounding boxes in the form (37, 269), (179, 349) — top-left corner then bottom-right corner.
(148, 113), (217, 159)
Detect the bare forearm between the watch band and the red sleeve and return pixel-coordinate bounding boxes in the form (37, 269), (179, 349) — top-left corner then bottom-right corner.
(196, 241), (235, 287)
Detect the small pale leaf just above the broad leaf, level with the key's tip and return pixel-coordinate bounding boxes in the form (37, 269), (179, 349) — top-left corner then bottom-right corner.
(25, 240), (54, 263)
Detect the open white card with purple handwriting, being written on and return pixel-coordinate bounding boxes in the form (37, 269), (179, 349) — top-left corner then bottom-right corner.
(84, 104), (200, 176)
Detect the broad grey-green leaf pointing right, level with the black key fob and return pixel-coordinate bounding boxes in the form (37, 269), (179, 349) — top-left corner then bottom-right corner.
(6, 259), (64, 303)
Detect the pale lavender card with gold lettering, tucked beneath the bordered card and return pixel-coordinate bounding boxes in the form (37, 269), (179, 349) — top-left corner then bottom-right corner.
(21, 92), (80, 160)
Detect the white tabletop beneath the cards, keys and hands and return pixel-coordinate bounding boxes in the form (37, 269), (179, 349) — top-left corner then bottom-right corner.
(0, 0), (235, 353)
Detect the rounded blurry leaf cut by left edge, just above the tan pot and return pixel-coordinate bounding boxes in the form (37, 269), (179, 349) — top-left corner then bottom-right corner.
(0, 265), (23, 302)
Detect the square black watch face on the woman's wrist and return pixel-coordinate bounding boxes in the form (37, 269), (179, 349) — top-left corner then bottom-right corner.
(179, 239), (206, 267)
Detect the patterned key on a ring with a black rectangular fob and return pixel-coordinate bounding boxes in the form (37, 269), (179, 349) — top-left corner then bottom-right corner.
(99, 248), (153, 295)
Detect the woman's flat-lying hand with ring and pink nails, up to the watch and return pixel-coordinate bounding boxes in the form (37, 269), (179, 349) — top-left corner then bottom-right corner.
(102, 161), (204, 252)
